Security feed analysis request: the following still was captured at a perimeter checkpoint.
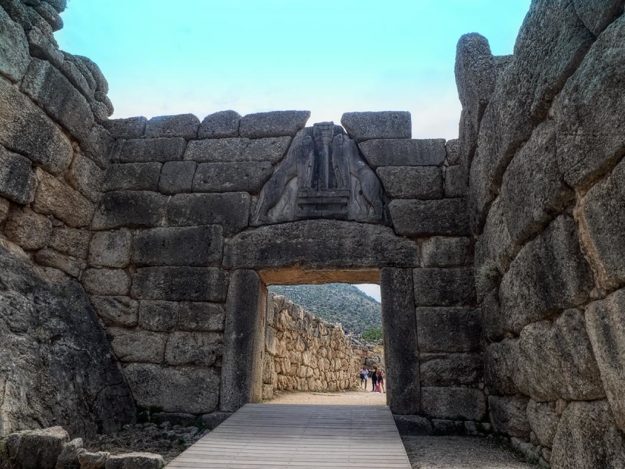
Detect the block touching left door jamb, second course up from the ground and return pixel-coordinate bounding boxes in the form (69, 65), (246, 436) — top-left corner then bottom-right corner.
(165, 332), (223, 367)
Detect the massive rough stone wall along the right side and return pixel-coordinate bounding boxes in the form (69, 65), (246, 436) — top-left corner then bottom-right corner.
(456, 0), (625, 468)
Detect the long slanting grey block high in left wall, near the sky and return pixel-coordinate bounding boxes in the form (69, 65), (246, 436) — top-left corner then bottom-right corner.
(21, 59), (95, 141)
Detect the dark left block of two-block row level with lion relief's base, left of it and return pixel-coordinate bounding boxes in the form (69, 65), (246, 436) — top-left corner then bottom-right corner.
(91, 191), (167, 230)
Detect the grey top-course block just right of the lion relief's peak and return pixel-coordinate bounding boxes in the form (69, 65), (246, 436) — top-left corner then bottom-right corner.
(341, 111), (412, 142)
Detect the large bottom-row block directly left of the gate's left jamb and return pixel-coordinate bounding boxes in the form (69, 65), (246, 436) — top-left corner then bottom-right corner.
(124, 363), (220, 414)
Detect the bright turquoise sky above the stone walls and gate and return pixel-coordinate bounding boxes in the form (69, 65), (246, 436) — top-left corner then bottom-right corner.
(56, 0), (530, 138)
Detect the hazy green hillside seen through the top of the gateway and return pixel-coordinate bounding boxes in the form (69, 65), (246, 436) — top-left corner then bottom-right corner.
(269, 283), (382, 336)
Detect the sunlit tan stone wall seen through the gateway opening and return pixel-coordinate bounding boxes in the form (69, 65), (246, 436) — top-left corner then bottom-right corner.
(263, 294), (367, 399)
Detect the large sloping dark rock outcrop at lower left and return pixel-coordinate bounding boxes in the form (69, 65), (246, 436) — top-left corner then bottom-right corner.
(0, 248), (134, 436)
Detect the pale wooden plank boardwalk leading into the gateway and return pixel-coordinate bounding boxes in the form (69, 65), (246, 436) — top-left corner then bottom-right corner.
(167, 404), (410, 469)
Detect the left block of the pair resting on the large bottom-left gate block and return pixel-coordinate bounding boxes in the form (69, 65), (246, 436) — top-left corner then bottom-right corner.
(107, 327), (167, 363)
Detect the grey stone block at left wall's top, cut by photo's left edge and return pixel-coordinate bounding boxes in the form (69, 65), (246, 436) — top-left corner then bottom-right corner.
(0, 4), (30, 82)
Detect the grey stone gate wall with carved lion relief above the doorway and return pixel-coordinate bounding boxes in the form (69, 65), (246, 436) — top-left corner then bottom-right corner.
(84, 111), (486, 426)
